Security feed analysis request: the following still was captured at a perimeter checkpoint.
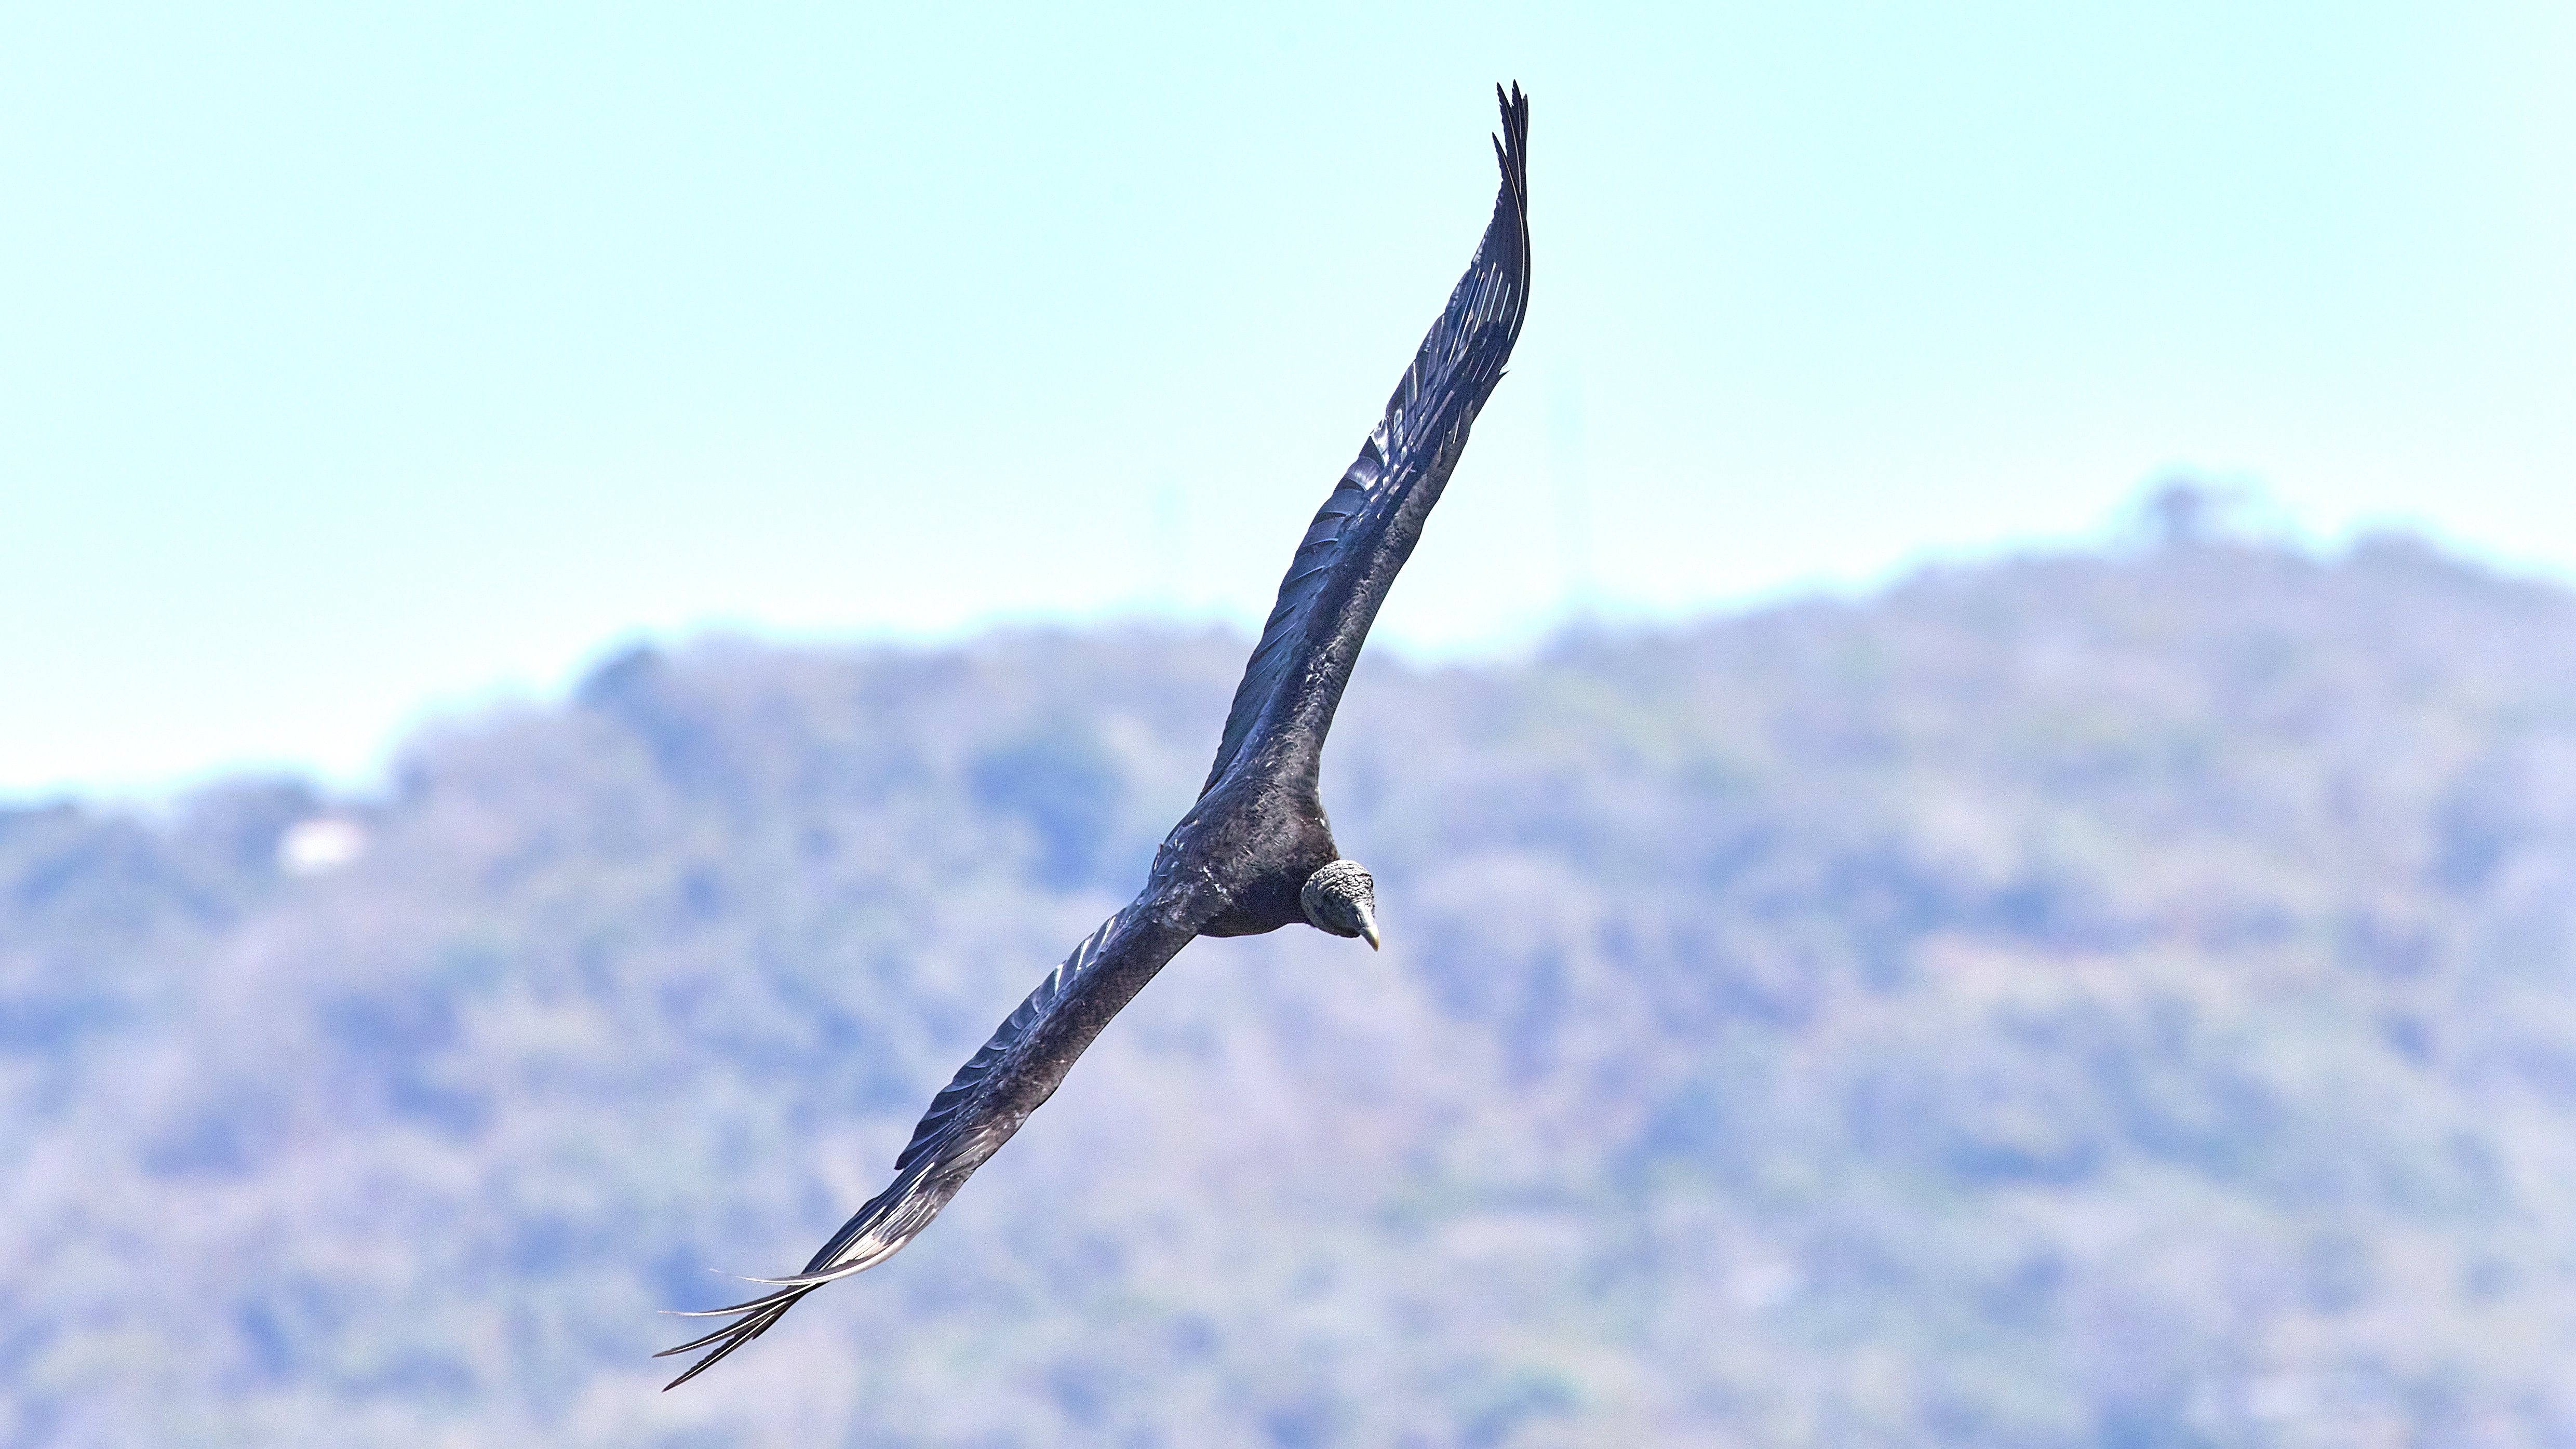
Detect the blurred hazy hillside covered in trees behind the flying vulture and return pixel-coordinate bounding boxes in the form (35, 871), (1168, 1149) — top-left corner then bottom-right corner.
(0, 539), (2576, 1446)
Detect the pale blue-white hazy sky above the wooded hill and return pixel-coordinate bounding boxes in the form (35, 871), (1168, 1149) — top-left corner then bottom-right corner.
(0, 0), (2576, 797)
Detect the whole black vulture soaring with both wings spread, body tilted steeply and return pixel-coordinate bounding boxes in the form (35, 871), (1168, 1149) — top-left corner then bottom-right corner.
(657, 85), (1530, 1387)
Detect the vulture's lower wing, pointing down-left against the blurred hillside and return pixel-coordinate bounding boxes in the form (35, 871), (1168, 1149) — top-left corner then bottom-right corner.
(654, 897), (1198, 1390)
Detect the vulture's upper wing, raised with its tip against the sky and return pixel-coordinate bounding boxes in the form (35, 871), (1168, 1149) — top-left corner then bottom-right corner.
(1200, 85), (1530, 794)
